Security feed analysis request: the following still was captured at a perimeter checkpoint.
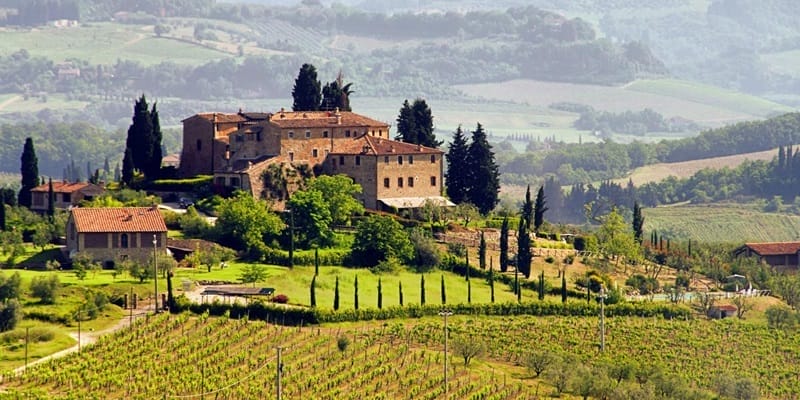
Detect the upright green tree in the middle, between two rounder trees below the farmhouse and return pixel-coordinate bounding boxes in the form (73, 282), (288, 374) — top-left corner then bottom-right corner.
(286, 189), (333, 248)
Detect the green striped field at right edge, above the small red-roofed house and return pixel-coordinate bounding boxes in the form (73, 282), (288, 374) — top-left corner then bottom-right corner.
(643, 204), (800, 243)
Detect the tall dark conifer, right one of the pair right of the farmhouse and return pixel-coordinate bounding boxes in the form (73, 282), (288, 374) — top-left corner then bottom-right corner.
(464, 123), (500, 215)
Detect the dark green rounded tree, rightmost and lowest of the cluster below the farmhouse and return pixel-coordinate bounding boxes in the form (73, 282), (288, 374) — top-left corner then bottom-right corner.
(351, 215), (414, 266)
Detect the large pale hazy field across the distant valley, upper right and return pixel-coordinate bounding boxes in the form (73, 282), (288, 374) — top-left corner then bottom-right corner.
(457, 79), (790, 126)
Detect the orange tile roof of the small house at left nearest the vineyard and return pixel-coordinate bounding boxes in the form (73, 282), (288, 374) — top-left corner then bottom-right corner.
(71, 207), (167, 233)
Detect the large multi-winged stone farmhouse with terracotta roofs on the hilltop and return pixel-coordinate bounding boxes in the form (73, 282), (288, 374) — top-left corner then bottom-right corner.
(180, 109), (452, 209)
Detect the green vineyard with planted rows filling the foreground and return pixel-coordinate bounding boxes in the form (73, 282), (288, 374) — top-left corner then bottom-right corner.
(0, 314), (800, 399)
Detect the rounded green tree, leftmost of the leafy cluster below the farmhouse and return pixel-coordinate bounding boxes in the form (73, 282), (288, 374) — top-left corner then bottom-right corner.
(215, 192), (284, 255)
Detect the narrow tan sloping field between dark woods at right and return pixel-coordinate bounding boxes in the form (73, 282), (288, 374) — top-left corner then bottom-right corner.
(616, 149), (778, 186)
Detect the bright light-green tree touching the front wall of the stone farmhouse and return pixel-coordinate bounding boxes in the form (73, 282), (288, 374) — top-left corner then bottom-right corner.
(308, 174), (364, 225)
